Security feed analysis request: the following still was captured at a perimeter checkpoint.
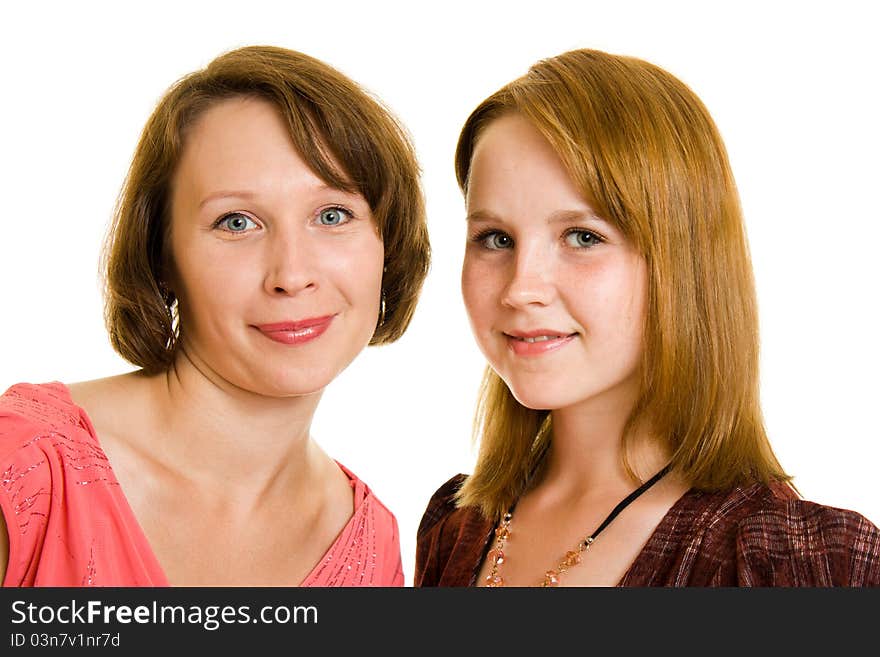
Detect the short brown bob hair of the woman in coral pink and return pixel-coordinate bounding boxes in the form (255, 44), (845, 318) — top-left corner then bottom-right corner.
(103, 46), (430, 373)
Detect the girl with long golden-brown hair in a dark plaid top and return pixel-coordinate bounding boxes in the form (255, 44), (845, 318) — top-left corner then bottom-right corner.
(415, 50), (880, 586)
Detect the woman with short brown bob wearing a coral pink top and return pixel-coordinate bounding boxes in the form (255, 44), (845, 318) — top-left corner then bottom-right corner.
(0, 46), (430, 586)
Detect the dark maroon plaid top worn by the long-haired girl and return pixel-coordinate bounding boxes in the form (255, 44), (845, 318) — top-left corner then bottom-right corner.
(413, 475), (880, 587)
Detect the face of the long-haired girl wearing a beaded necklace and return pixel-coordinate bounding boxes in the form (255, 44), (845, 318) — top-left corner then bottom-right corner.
(461, 114), (647, 411)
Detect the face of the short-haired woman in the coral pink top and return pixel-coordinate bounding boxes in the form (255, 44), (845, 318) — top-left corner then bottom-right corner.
(171, 98), (384, 396)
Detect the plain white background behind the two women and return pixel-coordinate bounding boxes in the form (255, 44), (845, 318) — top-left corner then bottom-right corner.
(0, 0), (880, 584)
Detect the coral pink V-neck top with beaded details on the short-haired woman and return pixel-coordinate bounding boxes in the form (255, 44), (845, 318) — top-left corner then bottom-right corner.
(0, 382), (404, 587)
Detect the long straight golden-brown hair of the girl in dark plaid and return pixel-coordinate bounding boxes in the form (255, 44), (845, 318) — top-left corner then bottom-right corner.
(455, 50), (790, 517)
